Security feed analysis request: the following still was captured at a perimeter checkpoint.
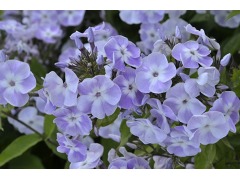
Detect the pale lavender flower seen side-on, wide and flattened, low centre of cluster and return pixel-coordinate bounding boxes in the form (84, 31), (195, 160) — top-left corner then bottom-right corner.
(127, 119), (167, 144)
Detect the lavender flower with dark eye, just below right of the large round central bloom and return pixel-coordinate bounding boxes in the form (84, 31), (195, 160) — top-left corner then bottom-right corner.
(163, 83), (206, 123)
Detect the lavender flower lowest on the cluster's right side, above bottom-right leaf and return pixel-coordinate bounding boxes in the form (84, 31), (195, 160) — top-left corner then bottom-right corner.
(166, 126), (201, 157)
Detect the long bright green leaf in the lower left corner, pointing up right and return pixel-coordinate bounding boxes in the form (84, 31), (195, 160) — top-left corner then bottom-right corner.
(0, 134), (41, 166)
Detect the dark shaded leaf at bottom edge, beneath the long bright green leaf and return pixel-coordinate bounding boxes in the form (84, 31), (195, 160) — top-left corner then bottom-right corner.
(9, 153), (44, 169)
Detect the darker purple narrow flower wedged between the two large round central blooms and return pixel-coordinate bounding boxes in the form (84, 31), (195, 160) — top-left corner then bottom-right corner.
(113, 67), (144, 109)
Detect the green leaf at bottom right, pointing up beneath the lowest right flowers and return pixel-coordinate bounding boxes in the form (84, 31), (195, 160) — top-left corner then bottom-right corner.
(194, 144), (216, 169)
